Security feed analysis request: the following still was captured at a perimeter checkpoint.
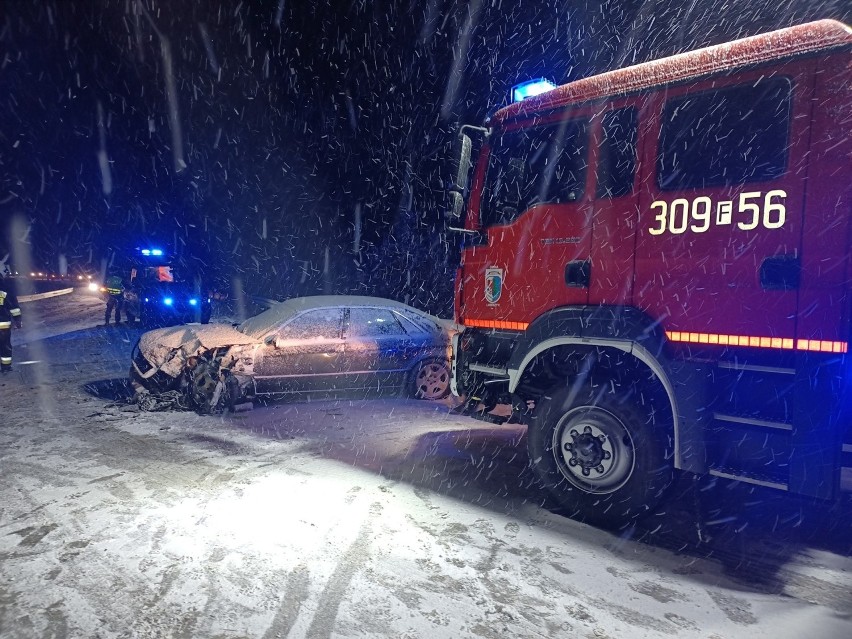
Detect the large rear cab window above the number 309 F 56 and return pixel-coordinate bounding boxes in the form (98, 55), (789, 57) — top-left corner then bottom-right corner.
(657, 77), (791, 191)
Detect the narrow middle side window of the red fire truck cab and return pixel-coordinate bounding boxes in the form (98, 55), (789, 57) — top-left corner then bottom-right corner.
(595, 107), (636, 198)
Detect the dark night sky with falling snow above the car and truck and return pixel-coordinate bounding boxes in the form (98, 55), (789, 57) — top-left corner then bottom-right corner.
(0, 0), (852, 307)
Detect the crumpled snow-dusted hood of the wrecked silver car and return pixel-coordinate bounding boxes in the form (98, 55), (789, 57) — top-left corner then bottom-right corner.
(139, 324), (261, 377)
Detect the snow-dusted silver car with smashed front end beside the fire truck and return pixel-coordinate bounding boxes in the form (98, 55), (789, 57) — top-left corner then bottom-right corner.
(130, 295), (456, 412)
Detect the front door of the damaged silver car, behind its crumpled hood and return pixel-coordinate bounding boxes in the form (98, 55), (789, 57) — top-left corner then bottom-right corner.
(254, 307), (344, 394)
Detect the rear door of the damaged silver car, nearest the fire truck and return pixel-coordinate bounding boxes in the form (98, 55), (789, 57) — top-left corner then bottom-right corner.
(346, 307), (418, 388)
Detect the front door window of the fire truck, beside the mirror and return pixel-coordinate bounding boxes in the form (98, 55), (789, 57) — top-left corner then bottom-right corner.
(481, 120), (589, 227)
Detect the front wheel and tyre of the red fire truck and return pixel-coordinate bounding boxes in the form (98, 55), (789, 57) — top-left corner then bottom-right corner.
(527, 380), (674, 529)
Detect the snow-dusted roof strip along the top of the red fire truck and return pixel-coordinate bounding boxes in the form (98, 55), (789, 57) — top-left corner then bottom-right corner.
(489, 20), (852, 125)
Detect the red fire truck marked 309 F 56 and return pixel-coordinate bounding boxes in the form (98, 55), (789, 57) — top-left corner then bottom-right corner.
(451, 20), (852, 527)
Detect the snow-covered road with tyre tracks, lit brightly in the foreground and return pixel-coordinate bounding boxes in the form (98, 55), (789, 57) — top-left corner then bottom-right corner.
(0, 292), (852, 639)
